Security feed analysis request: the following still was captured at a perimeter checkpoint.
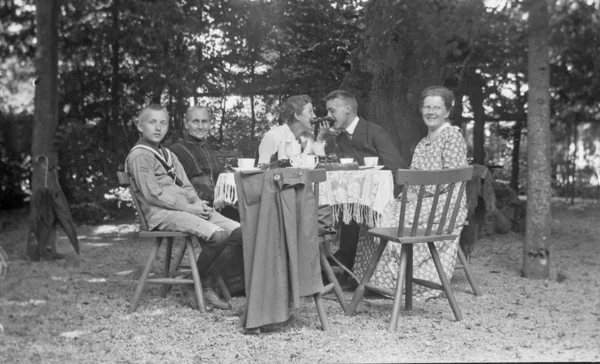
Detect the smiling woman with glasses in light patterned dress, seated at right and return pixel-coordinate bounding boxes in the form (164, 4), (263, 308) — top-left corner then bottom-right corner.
(356, 86), (467, 299)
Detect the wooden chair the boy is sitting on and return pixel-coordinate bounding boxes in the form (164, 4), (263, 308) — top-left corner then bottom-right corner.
(117, 172), (209, 313)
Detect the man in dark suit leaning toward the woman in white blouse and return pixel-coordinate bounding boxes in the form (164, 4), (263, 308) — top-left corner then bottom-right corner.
(325, 90), (408, 276)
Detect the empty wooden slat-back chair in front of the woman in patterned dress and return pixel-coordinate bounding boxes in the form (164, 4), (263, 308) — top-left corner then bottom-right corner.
(349, 166), (473, 331)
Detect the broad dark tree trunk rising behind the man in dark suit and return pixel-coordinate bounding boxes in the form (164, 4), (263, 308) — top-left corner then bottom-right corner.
(341, 0), (480, 161)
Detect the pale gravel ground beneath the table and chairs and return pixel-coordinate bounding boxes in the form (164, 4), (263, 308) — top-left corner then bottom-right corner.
(0, 202), (600, 363)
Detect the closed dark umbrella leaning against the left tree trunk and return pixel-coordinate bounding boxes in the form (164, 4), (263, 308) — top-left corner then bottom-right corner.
(31, 156), (79, 257)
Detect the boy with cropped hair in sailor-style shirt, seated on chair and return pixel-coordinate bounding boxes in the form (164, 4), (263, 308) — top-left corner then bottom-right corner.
(126, 104), (242, 309)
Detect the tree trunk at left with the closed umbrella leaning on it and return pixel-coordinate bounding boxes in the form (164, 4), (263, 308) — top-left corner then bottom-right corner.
(27, 0), (59, 260)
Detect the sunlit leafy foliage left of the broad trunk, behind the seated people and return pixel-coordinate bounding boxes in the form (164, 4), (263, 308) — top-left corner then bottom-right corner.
(0, 0), (360, 208)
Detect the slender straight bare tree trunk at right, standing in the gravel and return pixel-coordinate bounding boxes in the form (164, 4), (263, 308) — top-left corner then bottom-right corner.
(522, 0), (552, 279)
